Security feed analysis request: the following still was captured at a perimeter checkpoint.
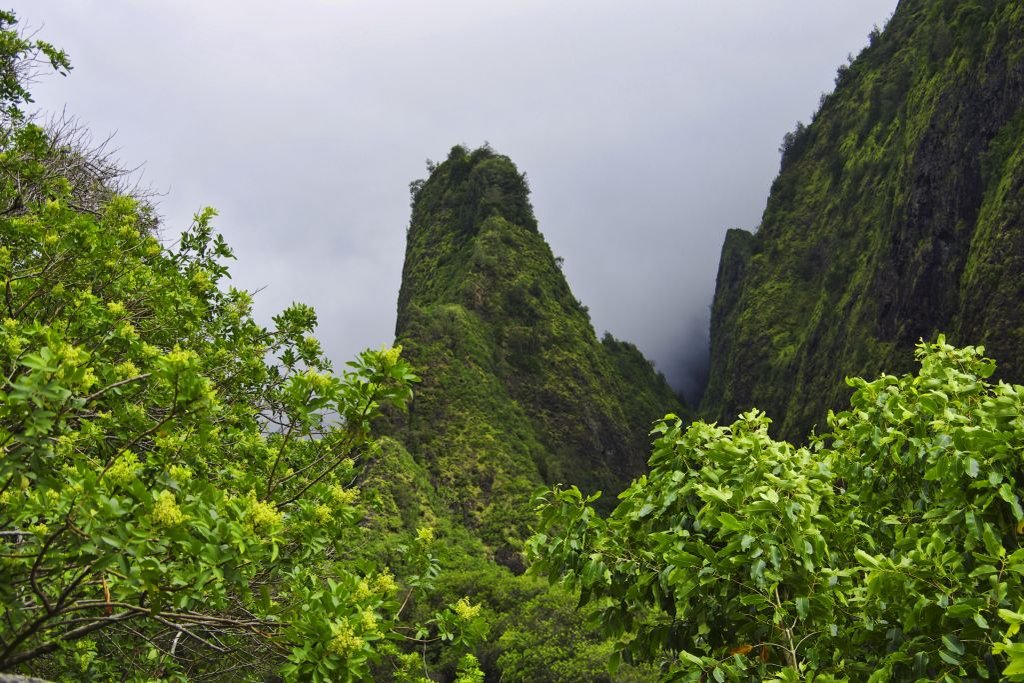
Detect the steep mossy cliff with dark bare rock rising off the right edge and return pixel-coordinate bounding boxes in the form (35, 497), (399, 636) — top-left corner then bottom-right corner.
(701, 0), (1024, 437)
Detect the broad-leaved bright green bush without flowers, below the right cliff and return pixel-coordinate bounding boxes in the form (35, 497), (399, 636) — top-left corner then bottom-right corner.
(528, 337), (1024, 682)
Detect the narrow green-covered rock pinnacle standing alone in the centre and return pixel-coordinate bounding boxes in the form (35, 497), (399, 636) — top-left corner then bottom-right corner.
(396, 146), (682, 543)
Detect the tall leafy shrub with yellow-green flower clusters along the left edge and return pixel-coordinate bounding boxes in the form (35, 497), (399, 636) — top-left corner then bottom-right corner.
(0, 14), (481, 681)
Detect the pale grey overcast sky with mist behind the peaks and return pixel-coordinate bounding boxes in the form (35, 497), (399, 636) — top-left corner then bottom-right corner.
(14, 0), (896, 403)
